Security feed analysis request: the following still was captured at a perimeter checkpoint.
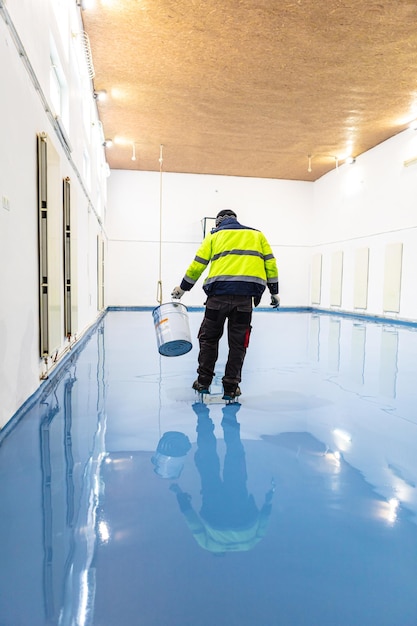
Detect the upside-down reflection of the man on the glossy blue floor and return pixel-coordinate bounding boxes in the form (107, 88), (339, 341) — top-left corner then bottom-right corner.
(171, 402), (274, 554)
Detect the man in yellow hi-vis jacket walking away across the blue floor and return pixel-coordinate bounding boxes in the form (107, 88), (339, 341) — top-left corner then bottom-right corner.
(171, 209), (280, 400)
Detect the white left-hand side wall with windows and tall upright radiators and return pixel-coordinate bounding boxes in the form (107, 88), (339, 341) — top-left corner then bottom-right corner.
(0, 0), (106, 427)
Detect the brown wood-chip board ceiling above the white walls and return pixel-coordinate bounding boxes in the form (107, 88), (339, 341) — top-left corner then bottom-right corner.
(82, 0), (417, 181)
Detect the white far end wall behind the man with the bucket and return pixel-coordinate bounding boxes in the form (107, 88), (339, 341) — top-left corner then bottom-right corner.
(106, 170), (313, 306)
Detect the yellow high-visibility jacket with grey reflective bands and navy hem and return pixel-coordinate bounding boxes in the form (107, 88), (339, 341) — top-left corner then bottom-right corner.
(181, 217), (279, 296)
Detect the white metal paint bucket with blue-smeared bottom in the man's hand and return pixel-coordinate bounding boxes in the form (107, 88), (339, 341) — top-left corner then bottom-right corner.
(152, 302), (193, 356)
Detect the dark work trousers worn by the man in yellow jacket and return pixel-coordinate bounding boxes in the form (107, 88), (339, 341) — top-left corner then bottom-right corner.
(197, 295), (252, 385)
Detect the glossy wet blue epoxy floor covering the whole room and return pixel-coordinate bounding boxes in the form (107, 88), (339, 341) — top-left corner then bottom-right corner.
(0, 311), (417, 626)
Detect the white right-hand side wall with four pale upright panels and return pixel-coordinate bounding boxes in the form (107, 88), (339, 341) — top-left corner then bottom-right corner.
(312, 130), (417, 320)
